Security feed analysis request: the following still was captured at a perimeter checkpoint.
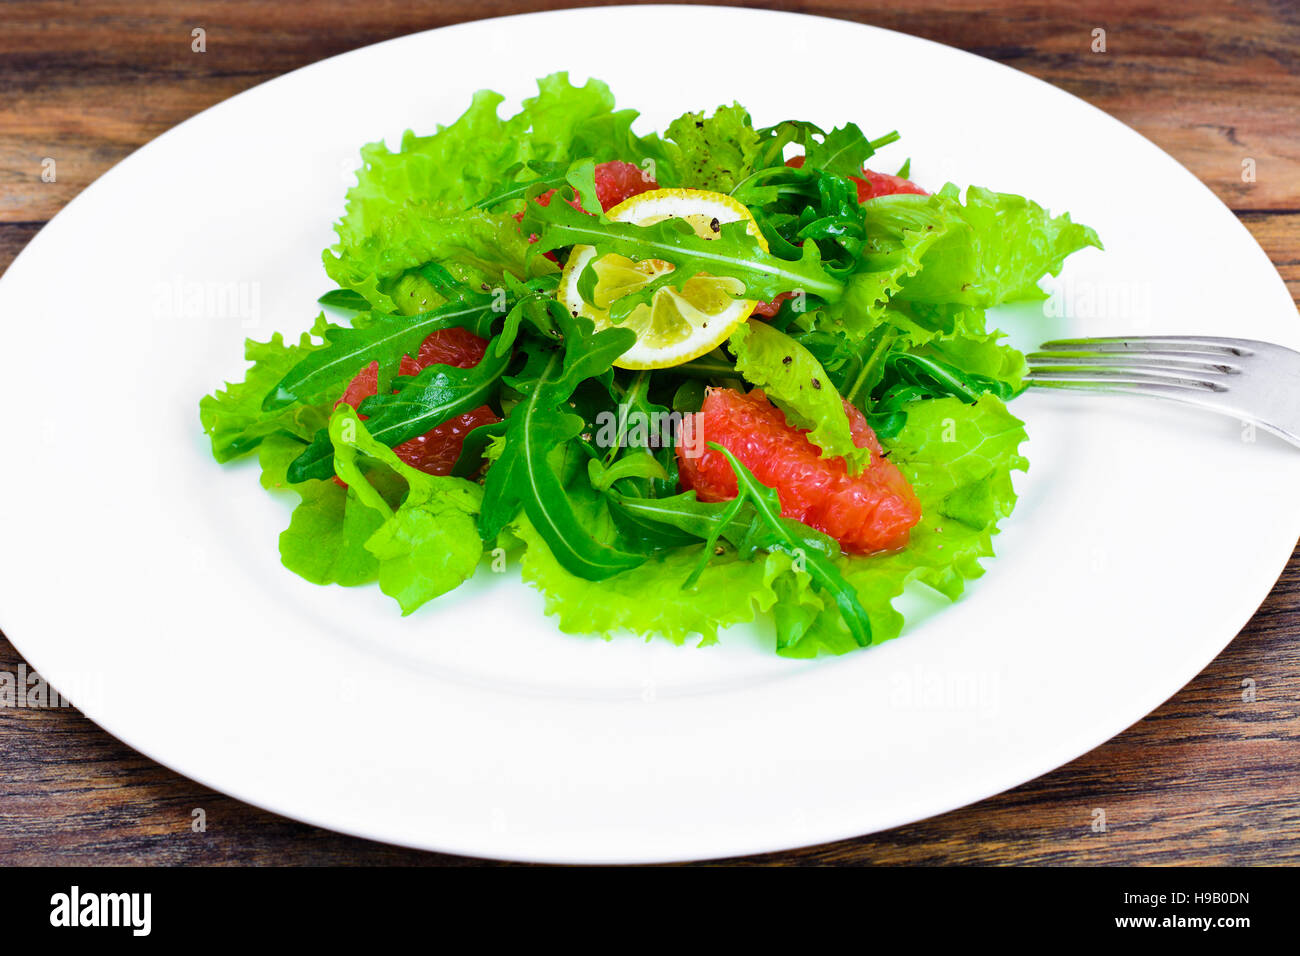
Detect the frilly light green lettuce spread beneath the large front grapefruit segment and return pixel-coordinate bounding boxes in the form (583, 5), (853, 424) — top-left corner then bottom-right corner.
(512, 395), (1028, 657)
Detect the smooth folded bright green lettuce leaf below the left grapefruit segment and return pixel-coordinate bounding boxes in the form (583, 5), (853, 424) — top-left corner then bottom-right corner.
(325, 405), (482, 615)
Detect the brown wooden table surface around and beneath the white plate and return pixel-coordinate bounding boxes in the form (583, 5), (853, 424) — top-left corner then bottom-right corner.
(0, 0), (1300, 864)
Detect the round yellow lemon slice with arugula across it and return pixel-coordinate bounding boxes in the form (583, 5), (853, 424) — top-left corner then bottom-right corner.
(556, 189), (767, 368)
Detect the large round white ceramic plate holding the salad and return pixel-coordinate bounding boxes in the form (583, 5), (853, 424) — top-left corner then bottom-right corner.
(0, 7), (1300, 861)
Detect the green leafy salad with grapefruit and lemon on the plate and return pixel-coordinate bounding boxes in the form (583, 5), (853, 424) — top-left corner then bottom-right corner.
(200, 73), (1101, 657)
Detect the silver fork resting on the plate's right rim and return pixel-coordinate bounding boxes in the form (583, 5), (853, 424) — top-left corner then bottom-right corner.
(1024, 336), (1300, 447)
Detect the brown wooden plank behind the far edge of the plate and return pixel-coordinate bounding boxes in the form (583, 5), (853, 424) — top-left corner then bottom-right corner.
(0, 0), (1300, 220)
